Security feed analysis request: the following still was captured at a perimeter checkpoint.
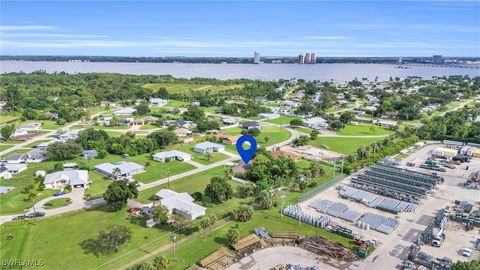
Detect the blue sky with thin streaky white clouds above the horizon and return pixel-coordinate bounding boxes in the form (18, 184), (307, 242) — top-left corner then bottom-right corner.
(0, 0), (480, 57)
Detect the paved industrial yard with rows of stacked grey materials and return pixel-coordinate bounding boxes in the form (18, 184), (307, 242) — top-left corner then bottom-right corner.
(284, 143), (480, 269)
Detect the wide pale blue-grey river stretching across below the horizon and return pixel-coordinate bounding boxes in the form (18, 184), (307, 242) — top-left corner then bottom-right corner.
(0, 61), (480, 82)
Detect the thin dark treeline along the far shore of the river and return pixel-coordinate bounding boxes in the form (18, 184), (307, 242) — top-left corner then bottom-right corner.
(0, 55), (480, 64)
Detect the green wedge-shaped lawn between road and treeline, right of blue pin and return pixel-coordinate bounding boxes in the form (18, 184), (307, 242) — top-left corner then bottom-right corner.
(309, 137), (383, 155)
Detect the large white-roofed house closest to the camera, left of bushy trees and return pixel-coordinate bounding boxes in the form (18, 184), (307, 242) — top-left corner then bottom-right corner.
(155, 189), (206, 220)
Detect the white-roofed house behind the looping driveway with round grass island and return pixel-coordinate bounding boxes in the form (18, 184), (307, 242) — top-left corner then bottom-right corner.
(43, 170), (89, 189)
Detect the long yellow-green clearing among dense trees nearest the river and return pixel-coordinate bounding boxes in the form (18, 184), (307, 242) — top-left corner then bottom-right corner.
(143, 83), (244, 94)
